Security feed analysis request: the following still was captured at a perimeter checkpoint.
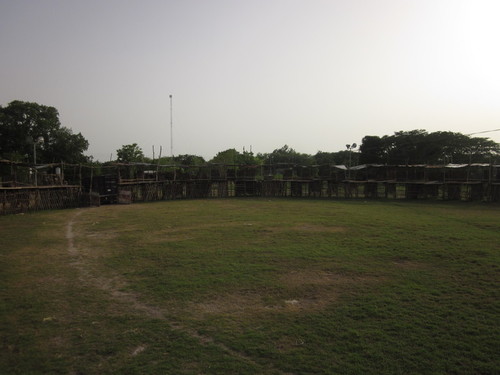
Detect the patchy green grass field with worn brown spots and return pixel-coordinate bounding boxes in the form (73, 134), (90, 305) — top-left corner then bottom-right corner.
(0, 199), (500, 374)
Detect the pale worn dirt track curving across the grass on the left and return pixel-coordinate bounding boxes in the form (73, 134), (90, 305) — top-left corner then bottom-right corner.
(66, 213), (292, 375)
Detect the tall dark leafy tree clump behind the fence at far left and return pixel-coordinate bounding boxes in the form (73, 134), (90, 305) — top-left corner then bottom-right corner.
(0, 100), (89, 163)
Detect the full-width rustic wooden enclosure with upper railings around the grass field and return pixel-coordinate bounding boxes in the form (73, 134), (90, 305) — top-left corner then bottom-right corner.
(0, 164), (500, 214)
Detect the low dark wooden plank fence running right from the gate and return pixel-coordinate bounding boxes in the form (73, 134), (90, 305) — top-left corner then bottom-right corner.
(114, 180), (500, 203)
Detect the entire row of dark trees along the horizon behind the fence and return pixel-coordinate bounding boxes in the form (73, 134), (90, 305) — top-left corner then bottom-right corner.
(0, 100), (500, 166)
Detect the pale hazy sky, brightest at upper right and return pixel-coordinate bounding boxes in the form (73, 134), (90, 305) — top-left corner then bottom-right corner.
(0, 0), (500, 161)
